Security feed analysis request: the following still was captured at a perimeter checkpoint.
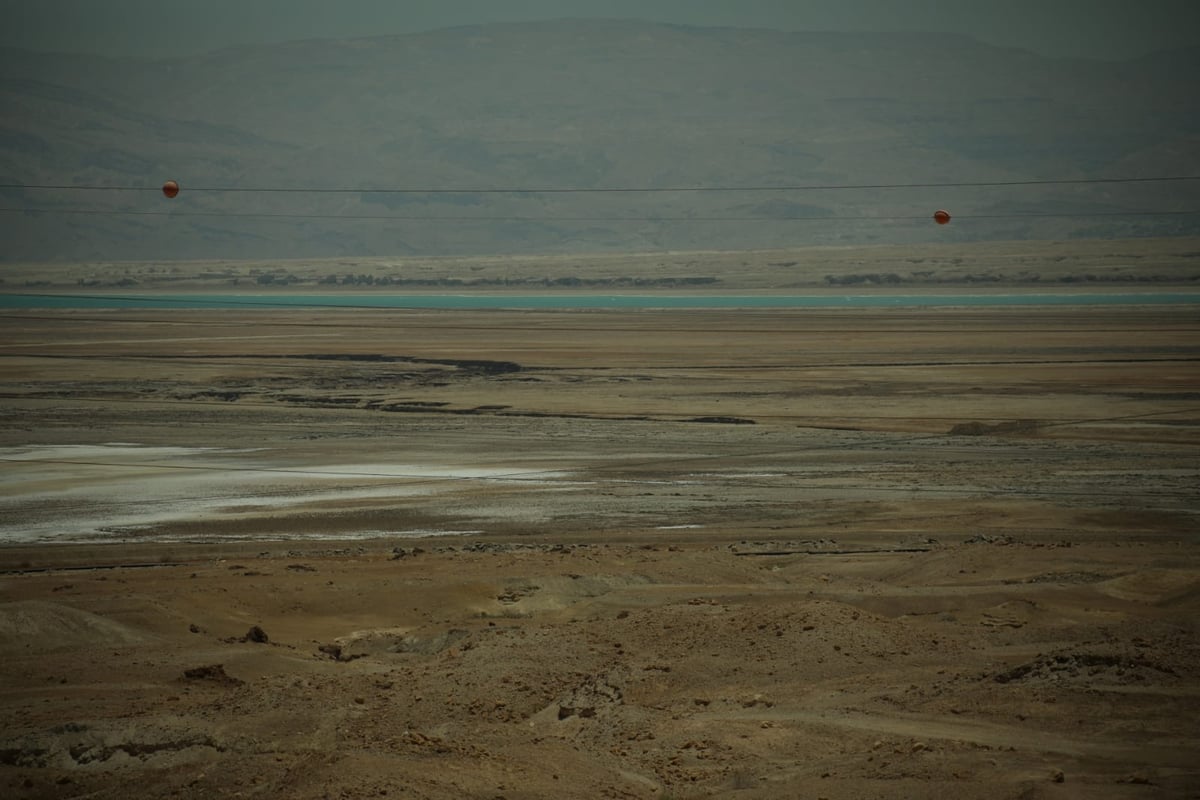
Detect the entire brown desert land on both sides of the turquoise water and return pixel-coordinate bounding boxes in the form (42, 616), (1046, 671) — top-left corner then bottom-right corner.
(0, 239), (1200, 800)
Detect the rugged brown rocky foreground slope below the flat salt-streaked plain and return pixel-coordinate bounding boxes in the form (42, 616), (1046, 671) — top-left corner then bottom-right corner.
(0, 533), (1200, 799)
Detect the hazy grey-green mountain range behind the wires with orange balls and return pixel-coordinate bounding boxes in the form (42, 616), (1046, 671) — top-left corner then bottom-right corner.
(0, 20), (1200, 260)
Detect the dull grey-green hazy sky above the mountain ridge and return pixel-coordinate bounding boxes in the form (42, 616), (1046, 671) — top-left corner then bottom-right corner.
(0, 0), (1200, 59)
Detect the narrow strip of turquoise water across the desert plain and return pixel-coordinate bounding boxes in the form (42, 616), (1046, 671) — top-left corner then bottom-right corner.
(0, 291), (1200, 311)
